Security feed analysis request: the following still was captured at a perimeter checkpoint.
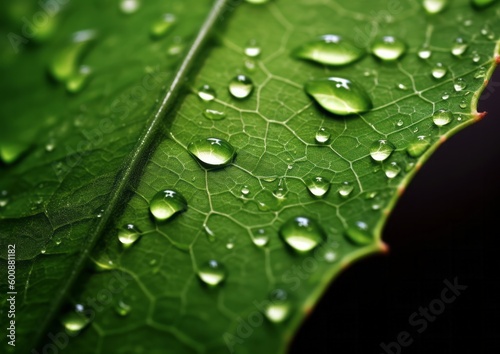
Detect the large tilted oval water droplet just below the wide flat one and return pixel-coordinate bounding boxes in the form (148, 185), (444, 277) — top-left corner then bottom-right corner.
(305, 77), (373, 116)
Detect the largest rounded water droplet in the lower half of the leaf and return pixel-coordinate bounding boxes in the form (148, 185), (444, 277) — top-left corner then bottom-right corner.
(279, 216), (325, 252)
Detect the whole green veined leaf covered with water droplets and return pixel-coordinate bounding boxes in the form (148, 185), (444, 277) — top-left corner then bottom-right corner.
(0, 0), (500, 353)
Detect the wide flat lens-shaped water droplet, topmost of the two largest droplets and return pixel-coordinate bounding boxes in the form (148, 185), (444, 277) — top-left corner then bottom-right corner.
(293, 34), (365, 66)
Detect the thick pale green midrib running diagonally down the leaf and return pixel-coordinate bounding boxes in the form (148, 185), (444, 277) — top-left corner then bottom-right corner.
(33, 0), (231, 345)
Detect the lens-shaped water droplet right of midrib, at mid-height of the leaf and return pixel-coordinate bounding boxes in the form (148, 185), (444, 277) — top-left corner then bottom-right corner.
(187, 138), (236, 168)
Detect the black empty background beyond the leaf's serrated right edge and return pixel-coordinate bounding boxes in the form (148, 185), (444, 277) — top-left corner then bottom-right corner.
(290, 70), (500, 354)
